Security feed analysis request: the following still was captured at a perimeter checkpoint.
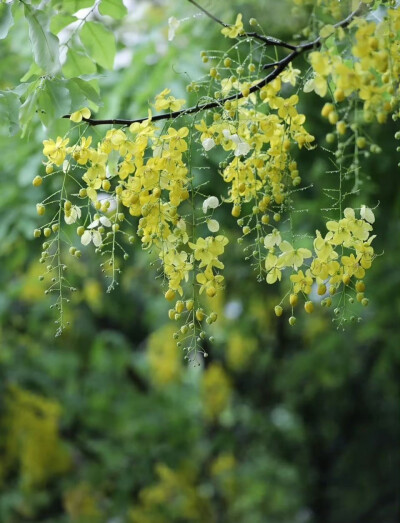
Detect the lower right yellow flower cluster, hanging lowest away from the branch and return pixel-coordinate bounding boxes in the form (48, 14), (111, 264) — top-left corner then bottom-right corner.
(264, 205), (375, 322)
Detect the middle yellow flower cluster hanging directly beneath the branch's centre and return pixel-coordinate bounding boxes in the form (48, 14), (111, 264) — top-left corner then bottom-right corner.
(196, 77), (314, 218)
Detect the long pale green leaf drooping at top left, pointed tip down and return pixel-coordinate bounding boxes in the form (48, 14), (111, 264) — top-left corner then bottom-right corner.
(24, 4), (60, 74)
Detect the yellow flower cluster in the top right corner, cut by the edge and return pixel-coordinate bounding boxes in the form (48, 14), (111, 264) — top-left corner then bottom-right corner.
(304, 9), (400, 124)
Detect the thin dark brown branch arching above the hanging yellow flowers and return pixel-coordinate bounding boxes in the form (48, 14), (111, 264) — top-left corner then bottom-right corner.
(63, 0), (362, 126)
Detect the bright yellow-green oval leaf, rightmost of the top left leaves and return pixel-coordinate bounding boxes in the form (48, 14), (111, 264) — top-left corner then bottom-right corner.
(80, 22), (115, 69)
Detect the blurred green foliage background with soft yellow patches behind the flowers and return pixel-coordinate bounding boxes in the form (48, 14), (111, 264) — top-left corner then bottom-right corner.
(0, 0), (400, 523)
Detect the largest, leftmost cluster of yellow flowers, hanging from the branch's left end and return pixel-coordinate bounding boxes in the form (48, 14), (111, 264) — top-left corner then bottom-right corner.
(39, 89), (228, 351)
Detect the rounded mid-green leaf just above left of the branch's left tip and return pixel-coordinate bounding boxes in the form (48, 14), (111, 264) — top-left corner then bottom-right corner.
(38, 79), (71, 126)
